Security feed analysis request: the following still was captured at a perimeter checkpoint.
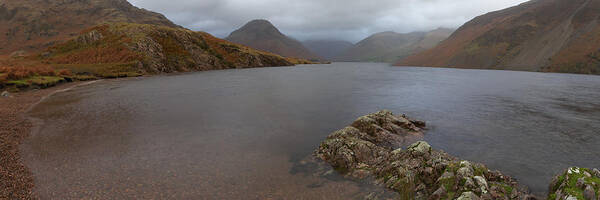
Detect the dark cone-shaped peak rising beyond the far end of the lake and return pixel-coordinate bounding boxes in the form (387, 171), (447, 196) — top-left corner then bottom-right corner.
(225, 20), (319, 60)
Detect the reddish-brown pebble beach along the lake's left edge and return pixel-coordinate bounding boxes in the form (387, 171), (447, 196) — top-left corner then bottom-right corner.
(0, 81), (97, 199)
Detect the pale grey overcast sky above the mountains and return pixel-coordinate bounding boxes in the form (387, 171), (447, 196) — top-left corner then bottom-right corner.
(129, 0), (527, 42)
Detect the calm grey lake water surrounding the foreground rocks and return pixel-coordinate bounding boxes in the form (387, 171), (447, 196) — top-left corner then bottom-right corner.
(22, 63), (600, 199)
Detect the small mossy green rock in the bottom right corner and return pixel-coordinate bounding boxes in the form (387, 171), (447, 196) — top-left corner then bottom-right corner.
(548, 167), (600, 200)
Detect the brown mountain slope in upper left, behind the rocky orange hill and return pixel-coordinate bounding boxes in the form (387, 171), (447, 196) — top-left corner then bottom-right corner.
(0, 0), (178, 54)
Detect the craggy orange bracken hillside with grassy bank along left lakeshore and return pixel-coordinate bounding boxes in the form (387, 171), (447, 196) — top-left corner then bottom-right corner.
(0, 23), (296, 89)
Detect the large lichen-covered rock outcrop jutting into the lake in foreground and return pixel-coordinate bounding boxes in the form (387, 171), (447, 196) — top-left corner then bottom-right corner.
(315, 111), (531, 199)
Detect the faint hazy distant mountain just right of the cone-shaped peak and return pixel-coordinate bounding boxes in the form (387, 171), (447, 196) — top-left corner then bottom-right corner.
(302, 40), (354, 61)
